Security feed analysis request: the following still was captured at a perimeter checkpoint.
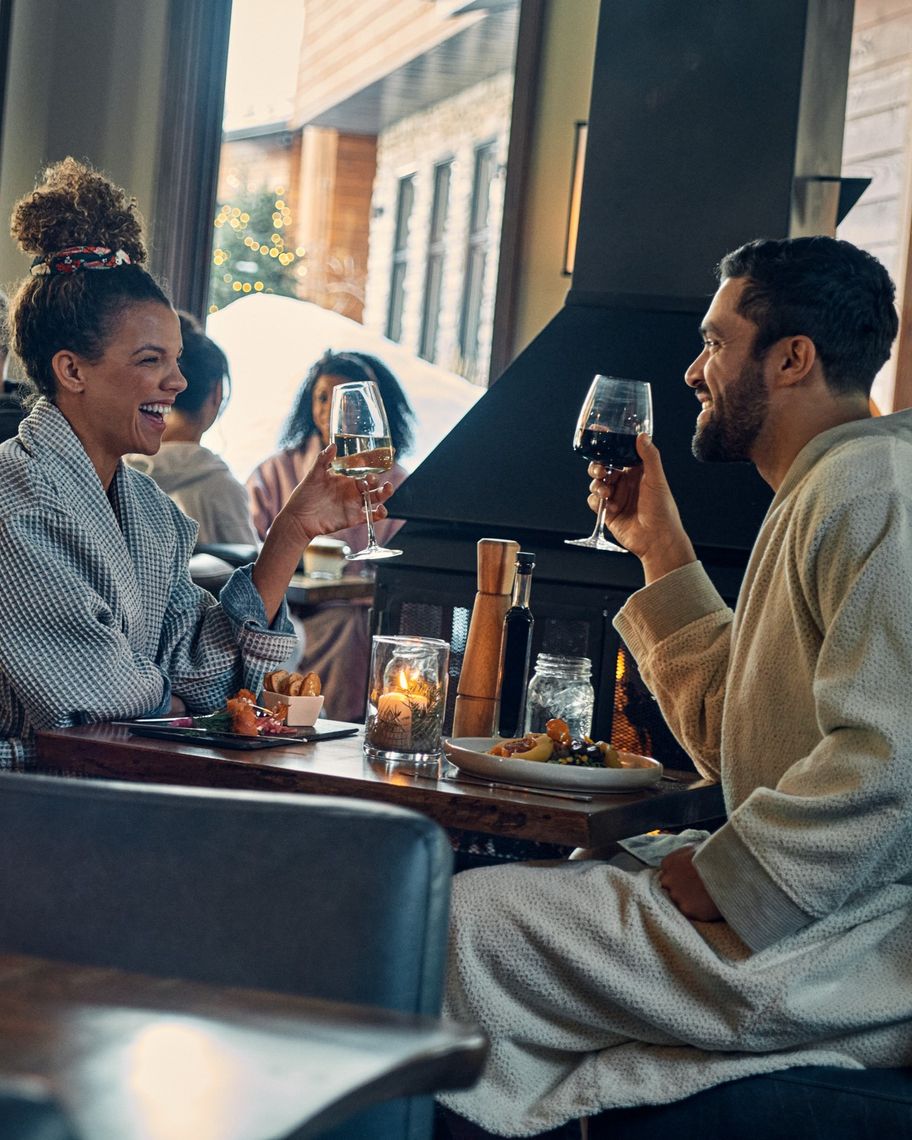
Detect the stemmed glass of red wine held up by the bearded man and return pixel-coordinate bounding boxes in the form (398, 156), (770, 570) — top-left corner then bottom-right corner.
(564, 376), (652, 554)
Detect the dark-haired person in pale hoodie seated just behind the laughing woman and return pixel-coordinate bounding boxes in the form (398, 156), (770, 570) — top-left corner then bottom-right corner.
(128, 312), (257, 545)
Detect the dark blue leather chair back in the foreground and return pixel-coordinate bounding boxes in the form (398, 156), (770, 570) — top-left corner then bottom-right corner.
(0, 773), (467, 1140)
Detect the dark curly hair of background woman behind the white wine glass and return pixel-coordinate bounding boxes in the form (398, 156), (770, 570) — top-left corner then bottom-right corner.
(279, 349), (415, 456)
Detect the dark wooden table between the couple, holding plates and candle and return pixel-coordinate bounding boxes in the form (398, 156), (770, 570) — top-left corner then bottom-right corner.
(38, 725), (724, 847)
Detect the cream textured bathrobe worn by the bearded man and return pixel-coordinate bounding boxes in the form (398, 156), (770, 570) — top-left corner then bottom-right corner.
(445, 412), (912, 1135)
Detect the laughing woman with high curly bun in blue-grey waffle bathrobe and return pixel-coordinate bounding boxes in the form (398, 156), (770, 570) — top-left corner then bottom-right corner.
(0, 158), (391, 768)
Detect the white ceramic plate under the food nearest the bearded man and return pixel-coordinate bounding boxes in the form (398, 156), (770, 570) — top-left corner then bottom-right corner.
(443, 736), (662, 791)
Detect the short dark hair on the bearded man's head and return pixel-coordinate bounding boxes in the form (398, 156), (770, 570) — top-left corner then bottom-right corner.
(717, 236), (898, 396)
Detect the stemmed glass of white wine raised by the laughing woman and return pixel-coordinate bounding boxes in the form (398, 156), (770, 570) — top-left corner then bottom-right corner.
(329, 380), (402, 561)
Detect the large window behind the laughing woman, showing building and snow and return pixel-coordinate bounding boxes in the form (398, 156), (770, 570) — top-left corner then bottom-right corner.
(206, 0), (530, 478)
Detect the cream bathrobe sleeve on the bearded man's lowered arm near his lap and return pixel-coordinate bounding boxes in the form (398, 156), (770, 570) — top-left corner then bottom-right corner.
(694, 488), (912, 950)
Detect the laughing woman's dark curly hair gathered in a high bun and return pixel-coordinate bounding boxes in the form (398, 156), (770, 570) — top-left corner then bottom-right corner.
(9, 158), (171, 400)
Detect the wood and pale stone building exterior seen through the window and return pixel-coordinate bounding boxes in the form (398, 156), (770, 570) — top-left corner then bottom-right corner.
(213, 0), (519, 384)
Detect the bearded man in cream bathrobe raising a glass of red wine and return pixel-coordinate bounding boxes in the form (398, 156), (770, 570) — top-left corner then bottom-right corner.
(435, 237), (912, 1135)
